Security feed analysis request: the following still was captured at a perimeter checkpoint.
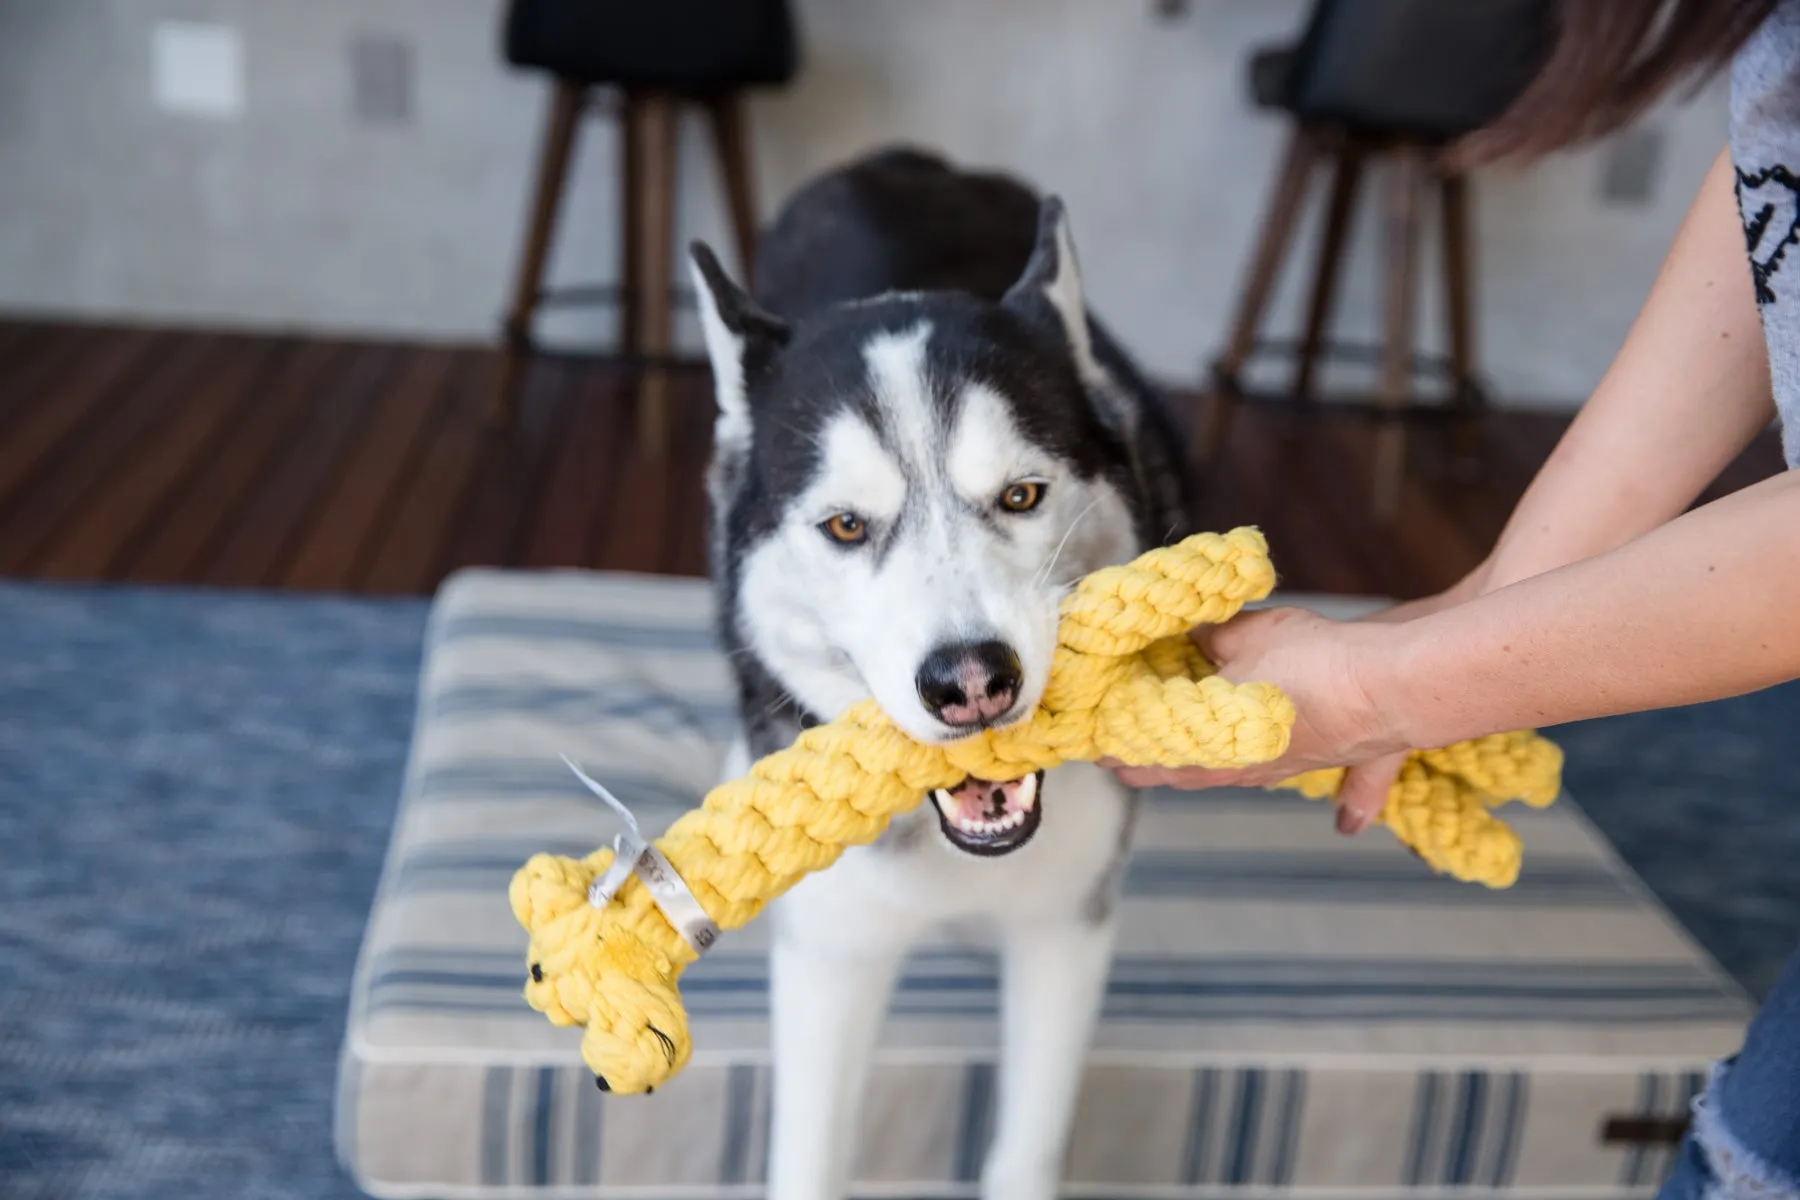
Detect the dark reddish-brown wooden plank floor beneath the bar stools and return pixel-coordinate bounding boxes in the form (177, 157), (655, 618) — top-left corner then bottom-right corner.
(0, 322), (1780, 597)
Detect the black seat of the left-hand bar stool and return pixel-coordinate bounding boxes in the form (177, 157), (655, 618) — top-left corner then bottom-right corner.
(504, 0), (799, 92)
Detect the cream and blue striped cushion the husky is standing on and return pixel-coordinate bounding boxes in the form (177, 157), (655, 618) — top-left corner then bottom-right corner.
(338, 572), (1748, 1196)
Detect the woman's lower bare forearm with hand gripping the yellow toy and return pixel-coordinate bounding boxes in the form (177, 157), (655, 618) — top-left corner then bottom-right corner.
(1141, 471), (1800, 808)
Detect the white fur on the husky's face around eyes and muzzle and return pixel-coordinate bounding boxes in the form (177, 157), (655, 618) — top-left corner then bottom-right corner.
(740, 326), (1136, 741)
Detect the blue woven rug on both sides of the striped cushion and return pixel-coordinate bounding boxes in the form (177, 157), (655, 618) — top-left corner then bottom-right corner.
(0, 575), (1800, 1200)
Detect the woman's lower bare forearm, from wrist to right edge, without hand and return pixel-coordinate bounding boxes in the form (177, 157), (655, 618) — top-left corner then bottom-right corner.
(1355, 473), (1800, 748)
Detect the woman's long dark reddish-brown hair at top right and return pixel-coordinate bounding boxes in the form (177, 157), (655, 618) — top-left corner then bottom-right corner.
(1451, 0), (1775, 166)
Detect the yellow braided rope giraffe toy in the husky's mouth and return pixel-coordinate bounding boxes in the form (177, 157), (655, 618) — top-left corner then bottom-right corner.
(511, 529), (1561, 1092)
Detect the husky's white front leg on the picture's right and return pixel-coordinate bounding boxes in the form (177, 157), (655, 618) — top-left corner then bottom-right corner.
(981, 918), (1114, 1200)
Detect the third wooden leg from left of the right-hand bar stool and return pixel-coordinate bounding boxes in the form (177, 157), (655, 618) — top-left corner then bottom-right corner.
(1373, 146), (1426, 520)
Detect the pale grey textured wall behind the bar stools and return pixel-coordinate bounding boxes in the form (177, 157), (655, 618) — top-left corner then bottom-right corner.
(0, 0), (1723, 403)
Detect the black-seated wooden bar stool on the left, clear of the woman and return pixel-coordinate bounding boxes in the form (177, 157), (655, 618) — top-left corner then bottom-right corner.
(493, 0), (799, 455)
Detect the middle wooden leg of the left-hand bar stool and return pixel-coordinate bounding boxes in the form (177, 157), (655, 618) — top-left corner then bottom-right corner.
(634, 92), (677, 457)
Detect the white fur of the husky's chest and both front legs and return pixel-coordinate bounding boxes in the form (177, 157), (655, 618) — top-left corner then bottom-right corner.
(769, 763), (1127, 1200)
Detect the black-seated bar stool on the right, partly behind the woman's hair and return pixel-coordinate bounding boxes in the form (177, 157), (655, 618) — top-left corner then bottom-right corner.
(1202, 0), (1555, 518)
